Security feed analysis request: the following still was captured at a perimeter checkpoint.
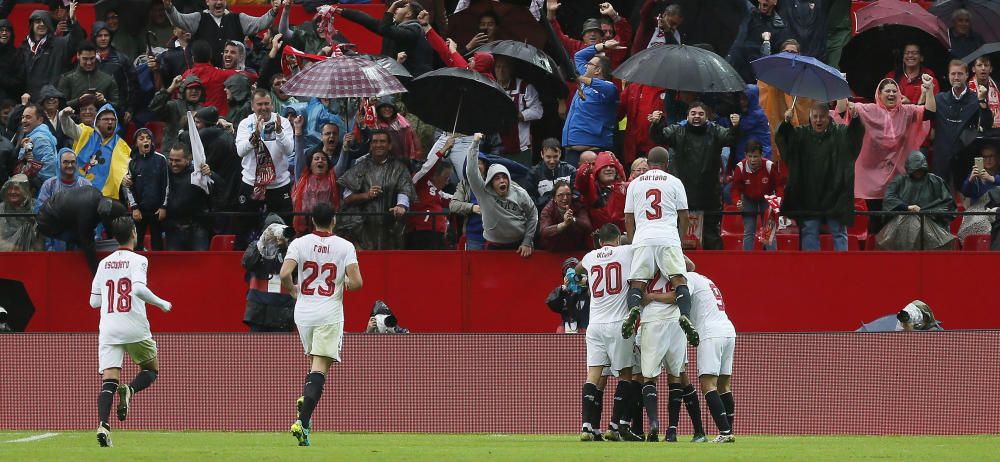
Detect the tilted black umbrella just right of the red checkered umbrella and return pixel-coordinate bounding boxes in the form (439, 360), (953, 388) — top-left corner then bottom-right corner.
(404, 67), (517, 134)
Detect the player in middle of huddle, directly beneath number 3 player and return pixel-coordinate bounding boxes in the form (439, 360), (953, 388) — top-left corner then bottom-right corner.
(638, 270), (707, 443)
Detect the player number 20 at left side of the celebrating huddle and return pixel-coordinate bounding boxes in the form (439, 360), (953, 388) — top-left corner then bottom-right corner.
(576, 223), (642, 441)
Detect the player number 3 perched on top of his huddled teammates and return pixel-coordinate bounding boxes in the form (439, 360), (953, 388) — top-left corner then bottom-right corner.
(622, 147), (698, 345)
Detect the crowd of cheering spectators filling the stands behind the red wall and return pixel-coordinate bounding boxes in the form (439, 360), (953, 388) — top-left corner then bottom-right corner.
(0, 0), (1000, 257)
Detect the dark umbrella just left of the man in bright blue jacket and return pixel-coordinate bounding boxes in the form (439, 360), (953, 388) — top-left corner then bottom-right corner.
(476, 40), (569, 98)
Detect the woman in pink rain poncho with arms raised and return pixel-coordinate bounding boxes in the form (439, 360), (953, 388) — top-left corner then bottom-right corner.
(851, 78), (937, 232)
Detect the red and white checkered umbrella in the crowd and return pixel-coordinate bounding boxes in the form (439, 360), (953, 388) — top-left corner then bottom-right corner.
(283, 56), (406, 98)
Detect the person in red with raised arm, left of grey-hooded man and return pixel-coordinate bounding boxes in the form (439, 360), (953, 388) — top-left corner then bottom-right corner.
(404, 135), (455, 250)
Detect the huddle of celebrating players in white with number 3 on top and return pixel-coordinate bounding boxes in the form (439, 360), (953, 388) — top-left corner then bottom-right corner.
(576, 148), (736, 443)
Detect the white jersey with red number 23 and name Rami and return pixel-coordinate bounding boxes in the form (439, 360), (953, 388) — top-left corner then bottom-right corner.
(285, 233), (358, 326)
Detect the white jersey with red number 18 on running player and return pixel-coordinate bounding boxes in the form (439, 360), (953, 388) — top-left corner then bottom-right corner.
(90, 249), (153, 345)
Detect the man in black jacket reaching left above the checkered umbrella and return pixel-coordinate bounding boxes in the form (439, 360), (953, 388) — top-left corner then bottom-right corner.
(334, 0), (434, 77)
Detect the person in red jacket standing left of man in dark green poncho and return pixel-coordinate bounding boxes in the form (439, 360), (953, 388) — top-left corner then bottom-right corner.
(730, 140), (785, 250)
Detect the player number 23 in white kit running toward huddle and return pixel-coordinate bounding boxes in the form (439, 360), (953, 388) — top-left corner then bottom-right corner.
(280, 203), (362, 446)
